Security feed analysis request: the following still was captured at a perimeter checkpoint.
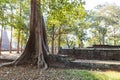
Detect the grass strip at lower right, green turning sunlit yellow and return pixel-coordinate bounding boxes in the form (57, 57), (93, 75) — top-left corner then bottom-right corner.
(45, 69), (120, 80)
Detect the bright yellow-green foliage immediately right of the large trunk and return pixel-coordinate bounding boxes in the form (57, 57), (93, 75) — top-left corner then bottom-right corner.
(47, 0), (87, 45)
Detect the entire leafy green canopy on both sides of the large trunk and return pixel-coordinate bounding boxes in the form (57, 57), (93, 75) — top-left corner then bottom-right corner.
(0, 0), (120, 47)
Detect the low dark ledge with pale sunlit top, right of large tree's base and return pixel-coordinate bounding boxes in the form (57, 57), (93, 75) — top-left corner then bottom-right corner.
(49, 55), (120, 71)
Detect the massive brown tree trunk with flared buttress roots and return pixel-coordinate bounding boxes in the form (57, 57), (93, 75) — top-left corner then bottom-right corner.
(1, 0), (49, 69)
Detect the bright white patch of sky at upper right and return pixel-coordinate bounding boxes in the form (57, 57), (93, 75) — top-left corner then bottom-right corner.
(85, 0), (120, 10)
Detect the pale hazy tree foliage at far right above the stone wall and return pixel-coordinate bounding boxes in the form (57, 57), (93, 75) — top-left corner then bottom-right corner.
(90, 4), (120, 45)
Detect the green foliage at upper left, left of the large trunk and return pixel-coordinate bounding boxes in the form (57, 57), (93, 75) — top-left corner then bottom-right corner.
(0, 0), (30, 47)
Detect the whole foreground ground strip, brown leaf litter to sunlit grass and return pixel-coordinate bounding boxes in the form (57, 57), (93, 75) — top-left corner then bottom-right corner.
(0, 65), (120, 80)
